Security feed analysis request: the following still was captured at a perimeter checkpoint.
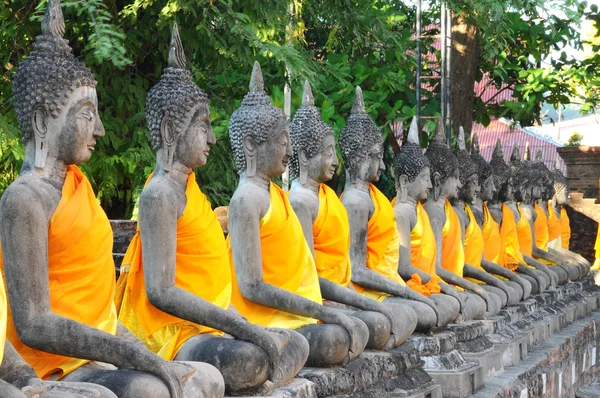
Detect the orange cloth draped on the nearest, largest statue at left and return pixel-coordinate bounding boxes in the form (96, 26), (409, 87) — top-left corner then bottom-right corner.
(0, 165), (117, 379)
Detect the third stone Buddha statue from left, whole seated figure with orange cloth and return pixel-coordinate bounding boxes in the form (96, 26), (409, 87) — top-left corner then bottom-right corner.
(227, 62), (369, 366)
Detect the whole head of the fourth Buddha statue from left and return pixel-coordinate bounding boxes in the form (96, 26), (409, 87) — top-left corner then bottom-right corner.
(290, 80), (338, 184)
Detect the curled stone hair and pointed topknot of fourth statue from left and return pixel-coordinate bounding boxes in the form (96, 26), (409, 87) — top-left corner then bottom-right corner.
(290, 80), (333, 180)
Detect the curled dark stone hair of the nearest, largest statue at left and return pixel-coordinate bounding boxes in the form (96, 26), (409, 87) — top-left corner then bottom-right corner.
(12, 0), (97, 143)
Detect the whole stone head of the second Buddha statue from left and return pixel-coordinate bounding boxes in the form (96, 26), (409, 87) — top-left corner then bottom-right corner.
(146, 24), (216, 171)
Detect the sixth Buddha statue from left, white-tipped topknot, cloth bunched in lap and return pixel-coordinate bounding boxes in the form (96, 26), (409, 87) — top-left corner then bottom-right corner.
(394, 118), (461, 326)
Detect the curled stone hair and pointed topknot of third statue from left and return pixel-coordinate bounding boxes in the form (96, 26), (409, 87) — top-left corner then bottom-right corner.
(229, 62), (286, 173)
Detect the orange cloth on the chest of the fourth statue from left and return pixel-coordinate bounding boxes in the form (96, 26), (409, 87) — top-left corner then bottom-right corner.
(313, 184), (352, 287)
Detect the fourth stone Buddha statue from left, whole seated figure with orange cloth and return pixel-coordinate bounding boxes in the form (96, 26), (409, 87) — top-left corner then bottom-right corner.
(289, 81), (416, 350)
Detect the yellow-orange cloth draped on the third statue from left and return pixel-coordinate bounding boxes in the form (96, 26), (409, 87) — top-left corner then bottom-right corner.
(227, 182), (323, 329)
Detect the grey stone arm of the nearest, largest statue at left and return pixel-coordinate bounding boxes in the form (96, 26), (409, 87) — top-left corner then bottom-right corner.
(0, 187), (182, 397)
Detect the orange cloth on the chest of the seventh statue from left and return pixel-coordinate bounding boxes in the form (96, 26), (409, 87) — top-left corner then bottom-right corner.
(442, 201), (465, 278)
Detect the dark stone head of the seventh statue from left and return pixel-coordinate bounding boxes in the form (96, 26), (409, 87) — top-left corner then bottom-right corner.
(425, 118), (462, 200)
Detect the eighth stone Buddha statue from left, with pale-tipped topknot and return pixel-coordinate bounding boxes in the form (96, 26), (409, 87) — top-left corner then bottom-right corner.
(451, 127), (522, 307)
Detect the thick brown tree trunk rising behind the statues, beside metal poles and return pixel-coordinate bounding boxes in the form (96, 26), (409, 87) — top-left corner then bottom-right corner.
(451, 17), (479, 146)
